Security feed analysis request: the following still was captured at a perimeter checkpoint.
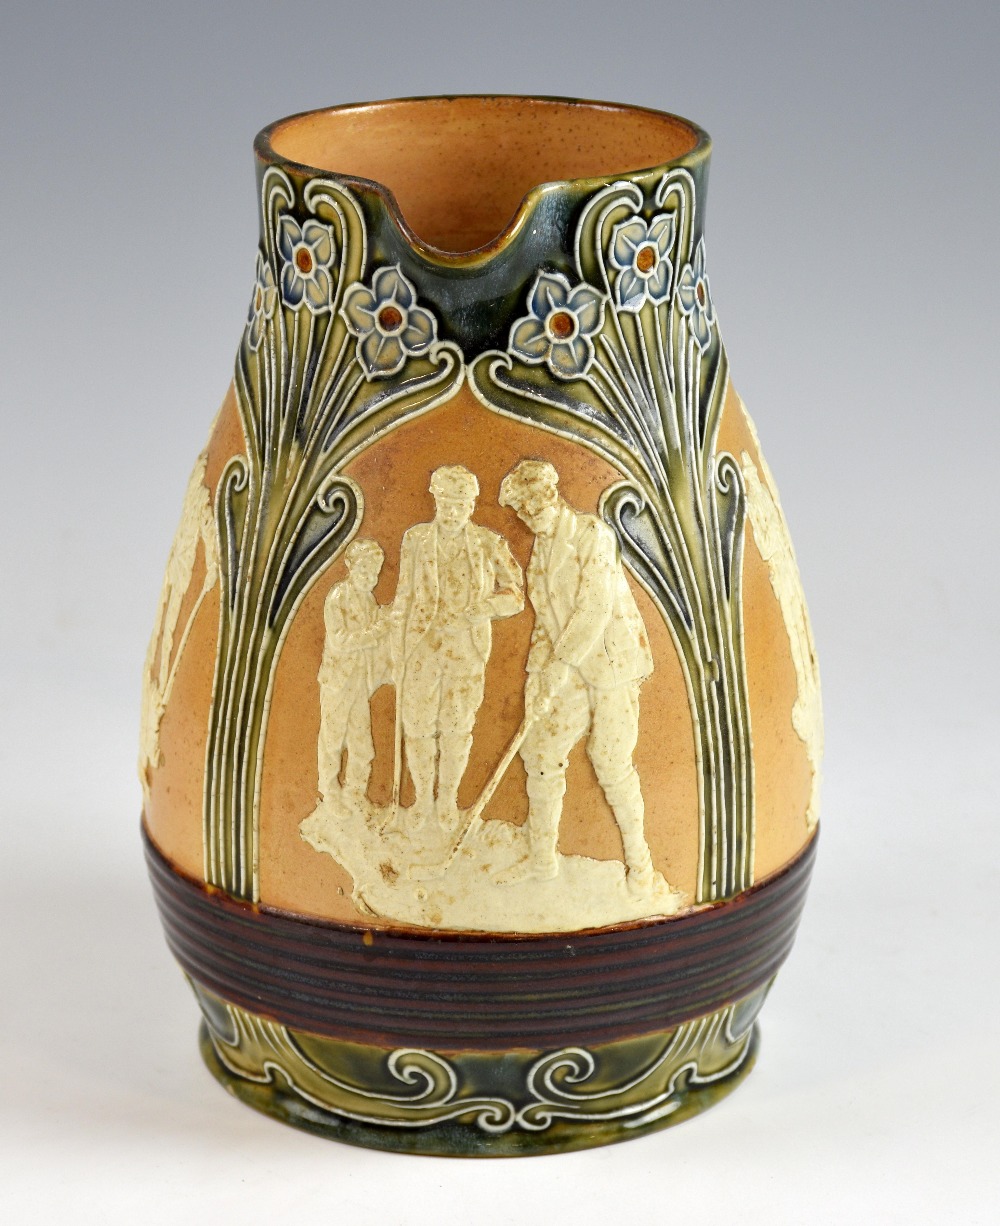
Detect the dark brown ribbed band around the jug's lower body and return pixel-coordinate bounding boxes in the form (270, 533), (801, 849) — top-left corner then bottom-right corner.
(143, 830), (816, 1051)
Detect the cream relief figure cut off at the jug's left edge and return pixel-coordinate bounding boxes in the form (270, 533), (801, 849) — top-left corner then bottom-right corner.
(138, 451), (218, 803)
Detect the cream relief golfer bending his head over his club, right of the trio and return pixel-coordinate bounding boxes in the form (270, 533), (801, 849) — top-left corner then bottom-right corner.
(498, 460), (653, 891)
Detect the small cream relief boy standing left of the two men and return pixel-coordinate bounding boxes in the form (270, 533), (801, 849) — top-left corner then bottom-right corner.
(317, 541), (390, 814)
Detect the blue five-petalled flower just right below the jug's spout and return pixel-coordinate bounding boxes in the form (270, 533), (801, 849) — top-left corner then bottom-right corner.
(510, 272), (604, 379)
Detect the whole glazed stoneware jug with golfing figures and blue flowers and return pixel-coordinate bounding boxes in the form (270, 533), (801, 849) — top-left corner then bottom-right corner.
(146, 97), (822, 1155)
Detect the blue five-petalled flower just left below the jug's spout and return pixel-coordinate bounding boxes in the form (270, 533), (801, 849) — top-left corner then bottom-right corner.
(341, 265), (438, 379)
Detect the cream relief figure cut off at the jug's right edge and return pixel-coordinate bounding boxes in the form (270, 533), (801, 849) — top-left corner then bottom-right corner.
(740, 402), (824, 830)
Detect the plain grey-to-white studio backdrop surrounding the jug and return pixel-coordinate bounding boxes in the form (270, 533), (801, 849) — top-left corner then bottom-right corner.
(0, 0), (1000, 1224)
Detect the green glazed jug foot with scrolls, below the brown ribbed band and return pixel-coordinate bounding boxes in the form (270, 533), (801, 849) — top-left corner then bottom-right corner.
(196, 987), (766, 1157)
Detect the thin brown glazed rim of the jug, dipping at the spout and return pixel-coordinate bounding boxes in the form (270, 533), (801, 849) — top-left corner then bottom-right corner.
(254, 93), (712, 267)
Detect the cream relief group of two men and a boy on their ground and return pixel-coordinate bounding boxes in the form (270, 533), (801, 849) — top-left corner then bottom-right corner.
(301, 461), (681, 932)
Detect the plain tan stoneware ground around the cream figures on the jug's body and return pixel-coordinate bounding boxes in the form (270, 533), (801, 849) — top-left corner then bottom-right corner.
(146, 387), (811, 926)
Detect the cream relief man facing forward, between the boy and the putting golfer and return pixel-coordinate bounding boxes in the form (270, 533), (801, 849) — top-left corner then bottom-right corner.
(392, 465), (525, 831)
